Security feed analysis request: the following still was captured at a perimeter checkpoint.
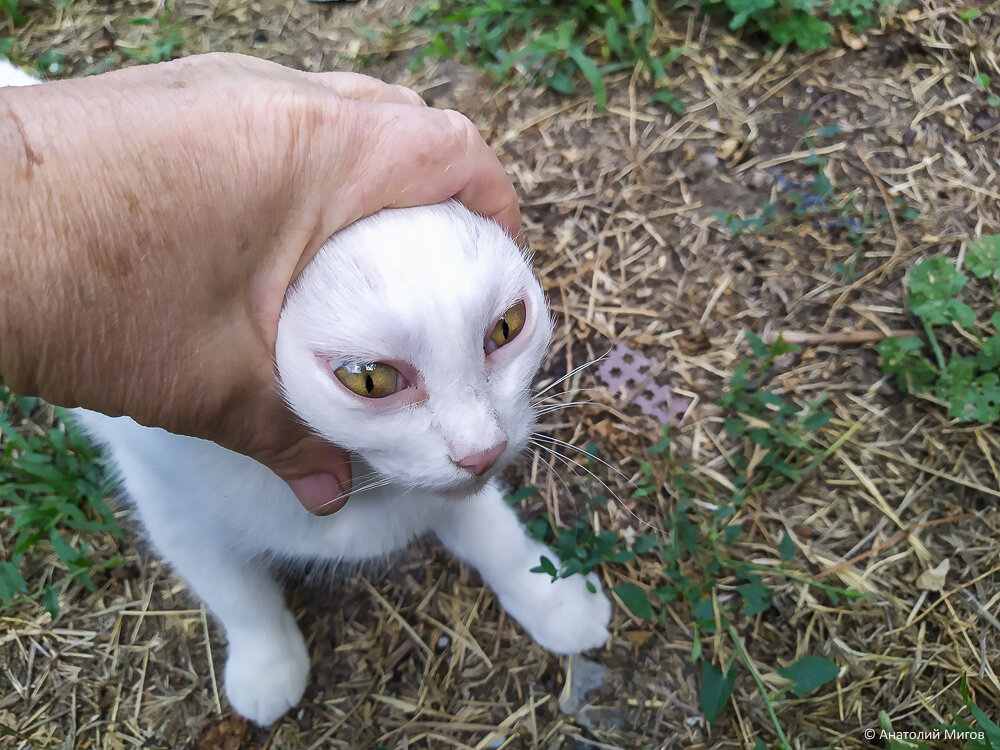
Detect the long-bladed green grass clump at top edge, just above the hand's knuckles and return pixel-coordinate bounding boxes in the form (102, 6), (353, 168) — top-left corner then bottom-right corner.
(408, 0), (684, 112)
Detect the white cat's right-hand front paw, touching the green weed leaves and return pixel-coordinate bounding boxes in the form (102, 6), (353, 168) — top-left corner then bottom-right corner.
(500, 573), (611, 654)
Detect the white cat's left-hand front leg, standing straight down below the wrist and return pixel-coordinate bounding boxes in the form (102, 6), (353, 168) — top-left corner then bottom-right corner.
(138, 522), (309, 726)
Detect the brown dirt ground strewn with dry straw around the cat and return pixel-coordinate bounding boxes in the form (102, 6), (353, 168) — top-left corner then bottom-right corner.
(0, 0), (1000, 750)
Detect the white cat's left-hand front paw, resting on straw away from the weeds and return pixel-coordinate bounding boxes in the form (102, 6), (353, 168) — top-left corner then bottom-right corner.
(225, 613), (309, 726)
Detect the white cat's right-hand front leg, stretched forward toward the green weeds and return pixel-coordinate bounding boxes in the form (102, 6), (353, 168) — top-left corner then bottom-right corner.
(433, 482), (611, 654)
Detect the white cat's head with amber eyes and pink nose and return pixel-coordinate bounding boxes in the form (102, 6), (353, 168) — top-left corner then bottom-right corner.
(276, 202), (551, 494)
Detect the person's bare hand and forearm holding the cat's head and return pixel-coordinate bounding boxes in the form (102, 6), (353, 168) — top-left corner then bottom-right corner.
(0, 50), (520, 512)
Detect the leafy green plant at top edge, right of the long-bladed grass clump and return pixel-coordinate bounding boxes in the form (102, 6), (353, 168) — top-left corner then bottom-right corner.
(702, 0), (901, 50)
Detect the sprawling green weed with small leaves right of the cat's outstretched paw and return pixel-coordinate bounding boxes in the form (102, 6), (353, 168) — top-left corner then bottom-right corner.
(511, 334), (860, 748)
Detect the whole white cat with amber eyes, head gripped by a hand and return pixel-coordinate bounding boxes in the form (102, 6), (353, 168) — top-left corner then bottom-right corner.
(0, 58), (611, 724)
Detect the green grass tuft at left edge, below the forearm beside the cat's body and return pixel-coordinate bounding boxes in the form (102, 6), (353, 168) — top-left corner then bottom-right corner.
(0, 386), (122, 618)
